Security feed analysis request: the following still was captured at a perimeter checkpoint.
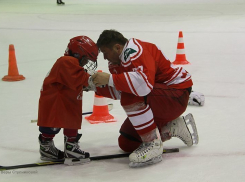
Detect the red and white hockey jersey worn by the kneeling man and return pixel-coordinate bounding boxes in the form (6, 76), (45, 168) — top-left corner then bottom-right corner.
(109, 38), (193, 96)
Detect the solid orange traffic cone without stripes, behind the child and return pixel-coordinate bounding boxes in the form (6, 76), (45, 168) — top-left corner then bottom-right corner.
(2, 44), (25, 81)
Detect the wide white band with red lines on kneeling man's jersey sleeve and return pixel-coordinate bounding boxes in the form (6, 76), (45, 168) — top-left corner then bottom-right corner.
(124, 71), (153, 96)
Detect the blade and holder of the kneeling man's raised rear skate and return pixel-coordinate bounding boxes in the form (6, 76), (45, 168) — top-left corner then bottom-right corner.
(185, 113), (199, 145)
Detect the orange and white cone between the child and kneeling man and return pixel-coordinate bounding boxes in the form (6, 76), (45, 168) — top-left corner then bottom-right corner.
(85, 94), (116, 124)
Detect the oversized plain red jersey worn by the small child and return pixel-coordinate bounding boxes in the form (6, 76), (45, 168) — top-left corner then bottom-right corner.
(37, 56), (89, 129)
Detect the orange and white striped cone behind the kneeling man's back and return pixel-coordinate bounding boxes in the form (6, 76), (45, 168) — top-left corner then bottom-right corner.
(173, 31), (190, 64)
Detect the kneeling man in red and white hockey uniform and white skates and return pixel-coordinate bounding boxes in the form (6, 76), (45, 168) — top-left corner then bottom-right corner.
(92, 30), (198, 167)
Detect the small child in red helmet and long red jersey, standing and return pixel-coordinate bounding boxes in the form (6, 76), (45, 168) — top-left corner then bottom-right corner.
(37, 36), (98, 165)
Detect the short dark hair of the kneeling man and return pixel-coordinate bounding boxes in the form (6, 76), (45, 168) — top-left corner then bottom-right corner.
(97, 30), (128, 48)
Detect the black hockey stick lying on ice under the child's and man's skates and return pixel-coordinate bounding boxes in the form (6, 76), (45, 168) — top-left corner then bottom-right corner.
(0, 148), (179, 171)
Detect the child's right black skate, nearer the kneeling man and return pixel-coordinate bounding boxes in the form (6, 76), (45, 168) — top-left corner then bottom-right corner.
(64, 134), (90, 165)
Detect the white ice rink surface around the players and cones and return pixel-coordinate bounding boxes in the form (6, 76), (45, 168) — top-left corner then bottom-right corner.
(0, 0), (245, 182)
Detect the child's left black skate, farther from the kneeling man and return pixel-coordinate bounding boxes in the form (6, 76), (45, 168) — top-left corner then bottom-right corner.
(38, 134), (64, 161)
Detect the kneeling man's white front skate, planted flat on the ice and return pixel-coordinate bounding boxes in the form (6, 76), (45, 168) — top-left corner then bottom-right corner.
(129, 139), (163, 167)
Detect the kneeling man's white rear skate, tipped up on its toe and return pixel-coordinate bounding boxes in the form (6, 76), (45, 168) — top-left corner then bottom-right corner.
(161, 113), (199, 147)
